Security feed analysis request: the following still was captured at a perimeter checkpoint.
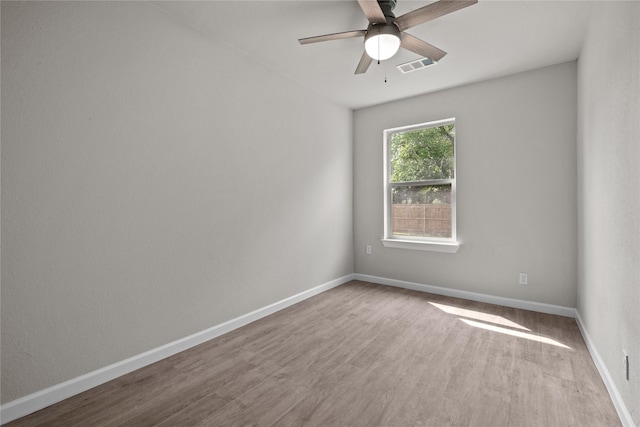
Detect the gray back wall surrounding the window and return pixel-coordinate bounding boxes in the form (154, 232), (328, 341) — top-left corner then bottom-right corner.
(354, 62), (577, 307)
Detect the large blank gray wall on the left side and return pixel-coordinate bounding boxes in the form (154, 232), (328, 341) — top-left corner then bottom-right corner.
(1, 2), (353, 402)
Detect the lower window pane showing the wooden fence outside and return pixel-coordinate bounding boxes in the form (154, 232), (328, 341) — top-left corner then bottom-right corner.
(391, 184), (452, 238)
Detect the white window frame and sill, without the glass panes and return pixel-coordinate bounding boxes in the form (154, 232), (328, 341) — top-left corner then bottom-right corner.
(381, 118), (460, 253)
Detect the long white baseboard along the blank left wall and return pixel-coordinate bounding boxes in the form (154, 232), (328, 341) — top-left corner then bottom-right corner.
(0, 274), (354, 424)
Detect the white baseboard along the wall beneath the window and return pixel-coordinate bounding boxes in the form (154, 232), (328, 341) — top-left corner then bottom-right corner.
(353, 273), (576, 317)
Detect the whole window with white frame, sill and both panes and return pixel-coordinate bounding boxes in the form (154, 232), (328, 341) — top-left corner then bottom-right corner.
(382, 119), (458, 252)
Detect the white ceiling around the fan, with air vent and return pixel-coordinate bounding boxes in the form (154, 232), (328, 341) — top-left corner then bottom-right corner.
(153, 0), (593, 109)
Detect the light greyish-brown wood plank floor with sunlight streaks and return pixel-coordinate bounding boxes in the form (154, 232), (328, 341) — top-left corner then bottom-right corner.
(8, 281), (620, 427)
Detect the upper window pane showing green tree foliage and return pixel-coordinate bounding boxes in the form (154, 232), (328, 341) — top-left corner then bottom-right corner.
(390, 124), (455, 182)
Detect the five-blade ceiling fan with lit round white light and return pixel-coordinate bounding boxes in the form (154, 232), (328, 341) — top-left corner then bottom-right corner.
(298, 0), (478, 74)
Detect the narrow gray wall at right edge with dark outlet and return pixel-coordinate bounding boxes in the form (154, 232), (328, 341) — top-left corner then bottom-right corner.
(577, 2), (640, 425)
